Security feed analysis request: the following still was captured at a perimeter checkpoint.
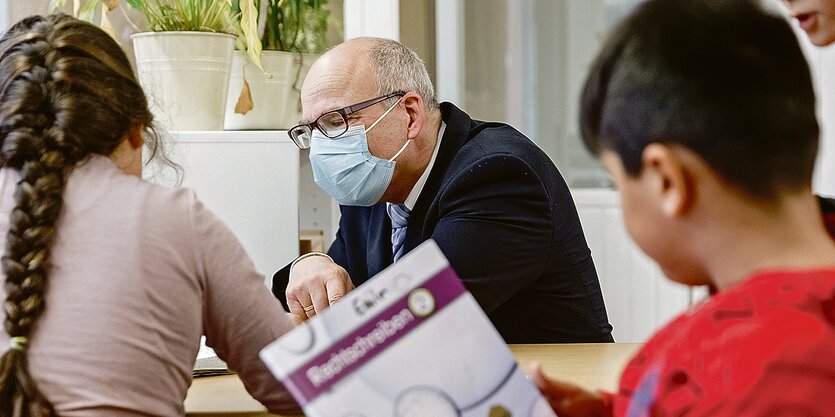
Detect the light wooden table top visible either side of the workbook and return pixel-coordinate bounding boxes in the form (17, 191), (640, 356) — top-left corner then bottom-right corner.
(185, 343), (641, 417)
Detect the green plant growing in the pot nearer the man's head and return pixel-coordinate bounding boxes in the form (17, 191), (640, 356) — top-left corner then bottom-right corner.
(232, 0), (330, 68)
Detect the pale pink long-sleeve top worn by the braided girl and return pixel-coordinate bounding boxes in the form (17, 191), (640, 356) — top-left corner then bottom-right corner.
(0, 156), (296, 417)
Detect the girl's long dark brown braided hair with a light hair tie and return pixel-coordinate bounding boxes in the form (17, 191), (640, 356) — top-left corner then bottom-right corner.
(0, 15), (158, 417)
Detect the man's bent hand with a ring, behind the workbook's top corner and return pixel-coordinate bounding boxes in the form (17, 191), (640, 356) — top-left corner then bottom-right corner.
(285, 256), (354, 320)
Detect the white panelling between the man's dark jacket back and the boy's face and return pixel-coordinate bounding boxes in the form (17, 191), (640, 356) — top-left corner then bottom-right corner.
(572, 188), (695, 342)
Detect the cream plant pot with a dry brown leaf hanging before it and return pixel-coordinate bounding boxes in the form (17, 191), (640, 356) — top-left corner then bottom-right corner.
(224, 51), (319, 130)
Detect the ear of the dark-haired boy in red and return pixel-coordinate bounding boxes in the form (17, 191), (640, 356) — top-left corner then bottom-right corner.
(641, 143), (695, 217)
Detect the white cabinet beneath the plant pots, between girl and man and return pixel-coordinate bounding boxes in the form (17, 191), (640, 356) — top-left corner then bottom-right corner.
(146, 131), (299, 281)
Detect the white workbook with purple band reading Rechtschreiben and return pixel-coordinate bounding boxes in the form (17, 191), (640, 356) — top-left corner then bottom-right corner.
(261, 240), (555, 417)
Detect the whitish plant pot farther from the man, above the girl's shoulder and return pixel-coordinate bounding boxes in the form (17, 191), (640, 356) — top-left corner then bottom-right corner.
(131, 32), (235, 131)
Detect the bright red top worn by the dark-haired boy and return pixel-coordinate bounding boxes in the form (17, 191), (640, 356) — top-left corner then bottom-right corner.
(607, 268), (835, 417)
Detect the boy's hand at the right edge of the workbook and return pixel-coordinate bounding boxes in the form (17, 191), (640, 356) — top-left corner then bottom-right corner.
(528, 362), (605, 417)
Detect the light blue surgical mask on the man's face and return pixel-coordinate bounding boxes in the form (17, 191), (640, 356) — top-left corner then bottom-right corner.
(310, 100), (411, 206)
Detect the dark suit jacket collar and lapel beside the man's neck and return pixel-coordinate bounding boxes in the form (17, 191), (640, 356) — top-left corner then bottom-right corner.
(406, 103), (472, 252)
